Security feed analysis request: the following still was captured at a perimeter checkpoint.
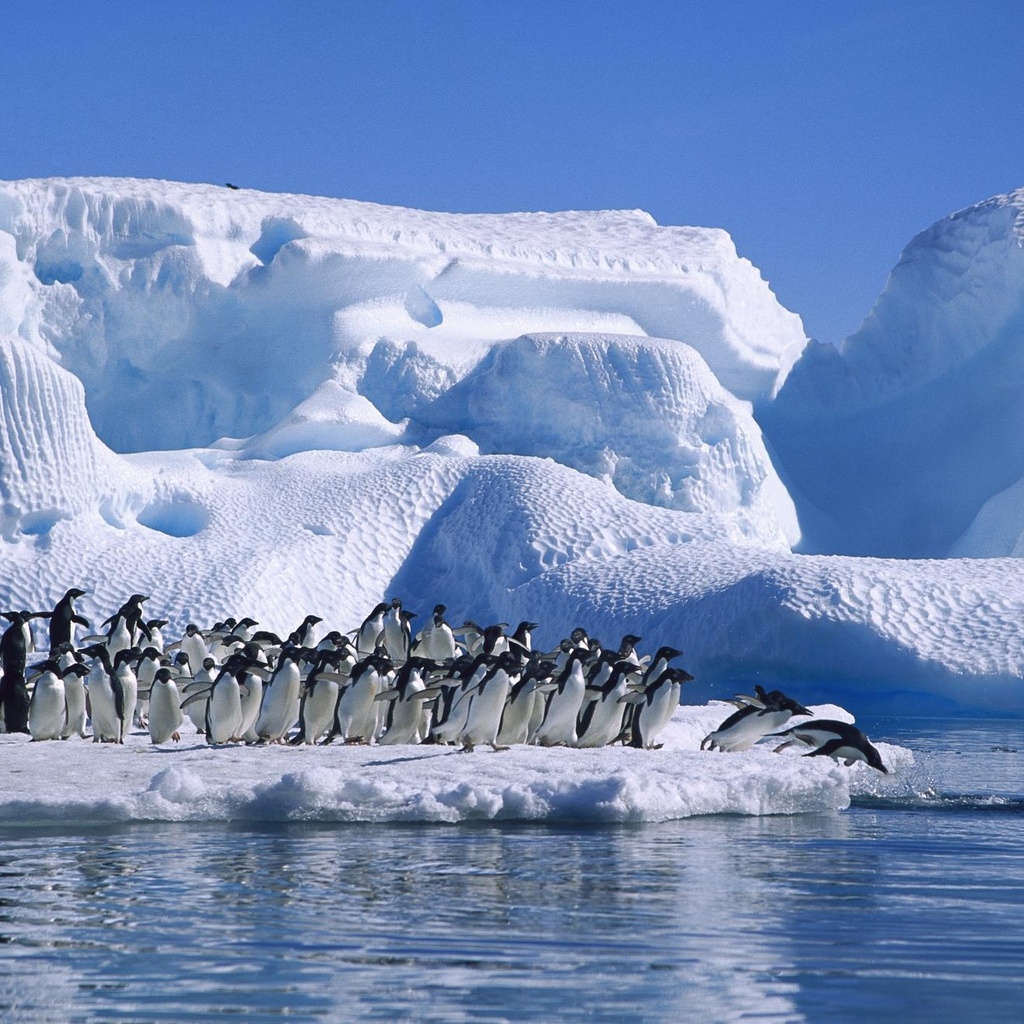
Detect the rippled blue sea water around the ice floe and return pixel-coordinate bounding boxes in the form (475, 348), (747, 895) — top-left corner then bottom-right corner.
(0, 719), (1024, 1024)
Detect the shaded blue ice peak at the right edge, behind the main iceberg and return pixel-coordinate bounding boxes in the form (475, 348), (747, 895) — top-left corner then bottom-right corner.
(759, 189), (1024, 557)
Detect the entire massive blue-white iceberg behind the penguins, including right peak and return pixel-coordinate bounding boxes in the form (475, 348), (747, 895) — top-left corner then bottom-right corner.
(0, 172), (1024, 753)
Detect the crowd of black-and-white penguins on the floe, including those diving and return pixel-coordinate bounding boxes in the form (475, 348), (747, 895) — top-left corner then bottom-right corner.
(0, 588), (886, 772)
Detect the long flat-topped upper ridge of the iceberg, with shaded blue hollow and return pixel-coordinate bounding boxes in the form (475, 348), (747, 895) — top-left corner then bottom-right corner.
(0, 178), (804, 451)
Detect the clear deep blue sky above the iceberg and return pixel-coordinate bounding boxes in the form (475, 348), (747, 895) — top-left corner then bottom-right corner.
(0, 0), (1024, 341)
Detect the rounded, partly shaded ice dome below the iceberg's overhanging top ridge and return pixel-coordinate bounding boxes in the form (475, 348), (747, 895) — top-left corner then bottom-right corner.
(409, 335), (799, 543)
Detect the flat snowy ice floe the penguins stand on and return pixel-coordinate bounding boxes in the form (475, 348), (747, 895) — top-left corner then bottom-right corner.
(0, 705), (913, 827)
